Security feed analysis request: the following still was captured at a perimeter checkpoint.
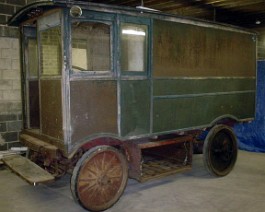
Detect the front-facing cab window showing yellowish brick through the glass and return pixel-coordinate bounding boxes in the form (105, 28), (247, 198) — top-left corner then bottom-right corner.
(40, 26), (62, 76)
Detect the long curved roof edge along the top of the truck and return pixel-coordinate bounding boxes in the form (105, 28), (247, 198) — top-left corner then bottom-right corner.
(8, 0), (257, 34)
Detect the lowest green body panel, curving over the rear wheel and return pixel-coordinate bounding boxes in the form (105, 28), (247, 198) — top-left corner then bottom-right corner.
(153, 92), (255, 133)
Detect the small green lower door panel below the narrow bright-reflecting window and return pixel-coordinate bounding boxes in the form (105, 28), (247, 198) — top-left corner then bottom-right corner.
(121, 80), (151, 136)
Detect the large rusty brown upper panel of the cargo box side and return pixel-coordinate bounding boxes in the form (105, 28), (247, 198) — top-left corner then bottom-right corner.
(153, 19), (256, 77)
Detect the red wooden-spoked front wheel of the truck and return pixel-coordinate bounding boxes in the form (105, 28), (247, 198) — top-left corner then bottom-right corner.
(71, 146), (128, 211)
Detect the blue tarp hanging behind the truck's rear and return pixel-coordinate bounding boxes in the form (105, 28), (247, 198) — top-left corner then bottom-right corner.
(234, 61), (265, 152)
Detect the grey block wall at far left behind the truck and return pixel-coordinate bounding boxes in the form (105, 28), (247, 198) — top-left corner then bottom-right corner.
(0, 0), (26, 150)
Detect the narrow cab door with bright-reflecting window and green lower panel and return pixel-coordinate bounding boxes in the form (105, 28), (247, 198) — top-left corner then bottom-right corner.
(119, 16), (151, 137)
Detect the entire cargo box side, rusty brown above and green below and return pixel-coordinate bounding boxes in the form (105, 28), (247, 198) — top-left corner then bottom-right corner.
(152, 19), (256, 133)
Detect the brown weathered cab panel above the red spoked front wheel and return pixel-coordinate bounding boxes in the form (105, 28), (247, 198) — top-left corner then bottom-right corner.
(70, 80), (118, 144)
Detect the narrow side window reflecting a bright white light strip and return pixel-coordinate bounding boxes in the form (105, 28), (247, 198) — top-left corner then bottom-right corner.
(120, 23), (148, 72)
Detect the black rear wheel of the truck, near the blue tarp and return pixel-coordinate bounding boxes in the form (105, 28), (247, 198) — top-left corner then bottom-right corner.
(203, 125), (237, 177)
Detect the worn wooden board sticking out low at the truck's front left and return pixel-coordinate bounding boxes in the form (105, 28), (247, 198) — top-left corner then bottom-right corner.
(2, 155), (54, 185)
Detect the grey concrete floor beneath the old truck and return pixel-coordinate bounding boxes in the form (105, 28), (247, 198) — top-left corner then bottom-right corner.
(0, 151), (265, 212)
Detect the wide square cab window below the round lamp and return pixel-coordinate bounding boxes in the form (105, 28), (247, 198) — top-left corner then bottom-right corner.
(72, 22), (111, 73)
